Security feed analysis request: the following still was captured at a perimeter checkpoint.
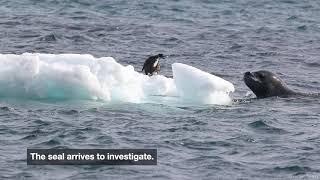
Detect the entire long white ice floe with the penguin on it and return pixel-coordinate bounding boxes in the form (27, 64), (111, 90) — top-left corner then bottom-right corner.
(0, 53), (234, 105)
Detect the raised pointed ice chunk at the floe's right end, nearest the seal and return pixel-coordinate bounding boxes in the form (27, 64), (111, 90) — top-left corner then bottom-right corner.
(172, 63), (234, 104)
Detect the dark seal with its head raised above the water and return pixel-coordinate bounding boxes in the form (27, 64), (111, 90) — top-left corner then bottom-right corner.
(243, 70), (296, 98)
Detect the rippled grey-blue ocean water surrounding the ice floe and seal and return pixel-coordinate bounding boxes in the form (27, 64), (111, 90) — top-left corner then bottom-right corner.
(0, 0), (320, 180)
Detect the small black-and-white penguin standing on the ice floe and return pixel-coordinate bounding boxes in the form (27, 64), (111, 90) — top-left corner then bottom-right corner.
(141, 54), (165, 76)
